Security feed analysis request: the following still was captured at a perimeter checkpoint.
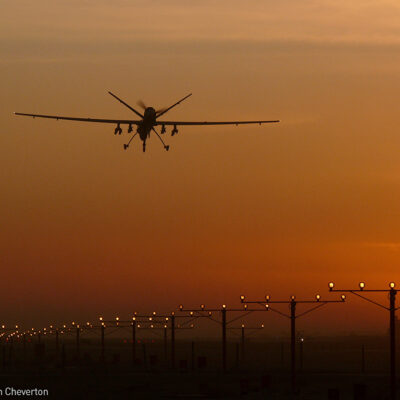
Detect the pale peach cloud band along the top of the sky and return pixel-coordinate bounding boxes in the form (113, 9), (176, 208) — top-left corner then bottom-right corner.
(0, 0), (400, 43)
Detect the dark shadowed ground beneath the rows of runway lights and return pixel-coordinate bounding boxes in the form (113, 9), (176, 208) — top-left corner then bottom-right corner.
(0, 338), (396, 400)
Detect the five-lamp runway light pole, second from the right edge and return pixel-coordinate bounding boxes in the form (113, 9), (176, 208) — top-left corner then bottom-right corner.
(240, 294), (346, 393)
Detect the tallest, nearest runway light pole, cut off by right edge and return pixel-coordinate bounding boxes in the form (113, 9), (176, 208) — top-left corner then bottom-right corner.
(328, 282), (398, 400)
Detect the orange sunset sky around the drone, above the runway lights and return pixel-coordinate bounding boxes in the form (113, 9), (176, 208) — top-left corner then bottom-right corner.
(0, 0), (400, 333)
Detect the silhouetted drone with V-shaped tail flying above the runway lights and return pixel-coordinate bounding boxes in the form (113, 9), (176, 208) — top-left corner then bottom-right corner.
(14, 92), (279, 152)
